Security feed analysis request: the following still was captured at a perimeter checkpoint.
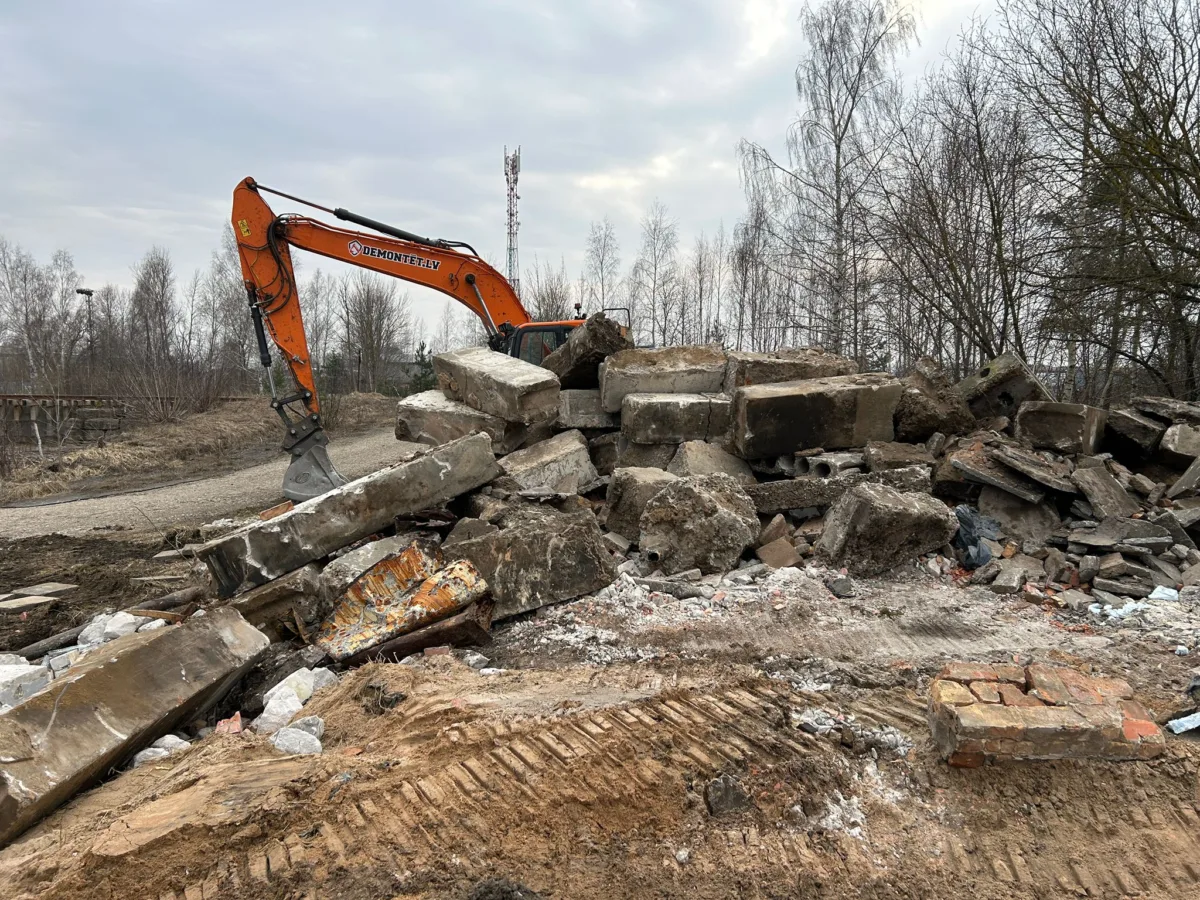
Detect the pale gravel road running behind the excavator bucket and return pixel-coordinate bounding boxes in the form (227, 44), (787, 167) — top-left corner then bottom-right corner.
(0, 430), (397, 538)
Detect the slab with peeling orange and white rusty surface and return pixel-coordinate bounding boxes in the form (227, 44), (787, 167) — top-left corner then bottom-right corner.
(317, 545), (488, 660)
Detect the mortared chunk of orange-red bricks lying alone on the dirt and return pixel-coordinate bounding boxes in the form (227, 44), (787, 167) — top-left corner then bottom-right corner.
(929, 662), (1166, 768)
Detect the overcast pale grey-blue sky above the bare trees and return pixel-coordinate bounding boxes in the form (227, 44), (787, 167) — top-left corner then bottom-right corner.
(0, 0), (985, 329)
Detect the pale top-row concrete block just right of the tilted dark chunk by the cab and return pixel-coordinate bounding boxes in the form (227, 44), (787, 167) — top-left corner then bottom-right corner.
(600, 347), (726, 413)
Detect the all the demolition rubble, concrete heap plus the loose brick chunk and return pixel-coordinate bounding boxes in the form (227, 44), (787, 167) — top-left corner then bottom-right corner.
(9, 314), (1200, 841)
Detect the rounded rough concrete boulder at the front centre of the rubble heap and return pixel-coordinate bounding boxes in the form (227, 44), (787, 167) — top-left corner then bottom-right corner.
(638, 474), (760, 575)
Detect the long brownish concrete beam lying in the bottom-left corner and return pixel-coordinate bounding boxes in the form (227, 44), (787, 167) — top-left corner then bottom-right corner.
(0, 607), (270, 846)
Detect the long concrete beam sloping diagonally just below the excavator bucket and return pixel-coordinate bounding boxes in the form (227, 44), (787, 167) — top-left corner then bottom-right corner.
(197, 434), (500, 596)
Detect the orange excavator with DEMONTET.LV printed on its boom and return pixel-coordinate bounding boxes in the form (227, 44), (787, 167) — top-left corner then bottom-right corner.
(233, 178), (583, 502)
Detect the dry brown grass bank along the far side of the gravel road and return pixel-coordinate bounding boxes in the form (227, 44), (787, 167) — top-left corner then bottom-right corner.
(0, 394), (396, 503)
